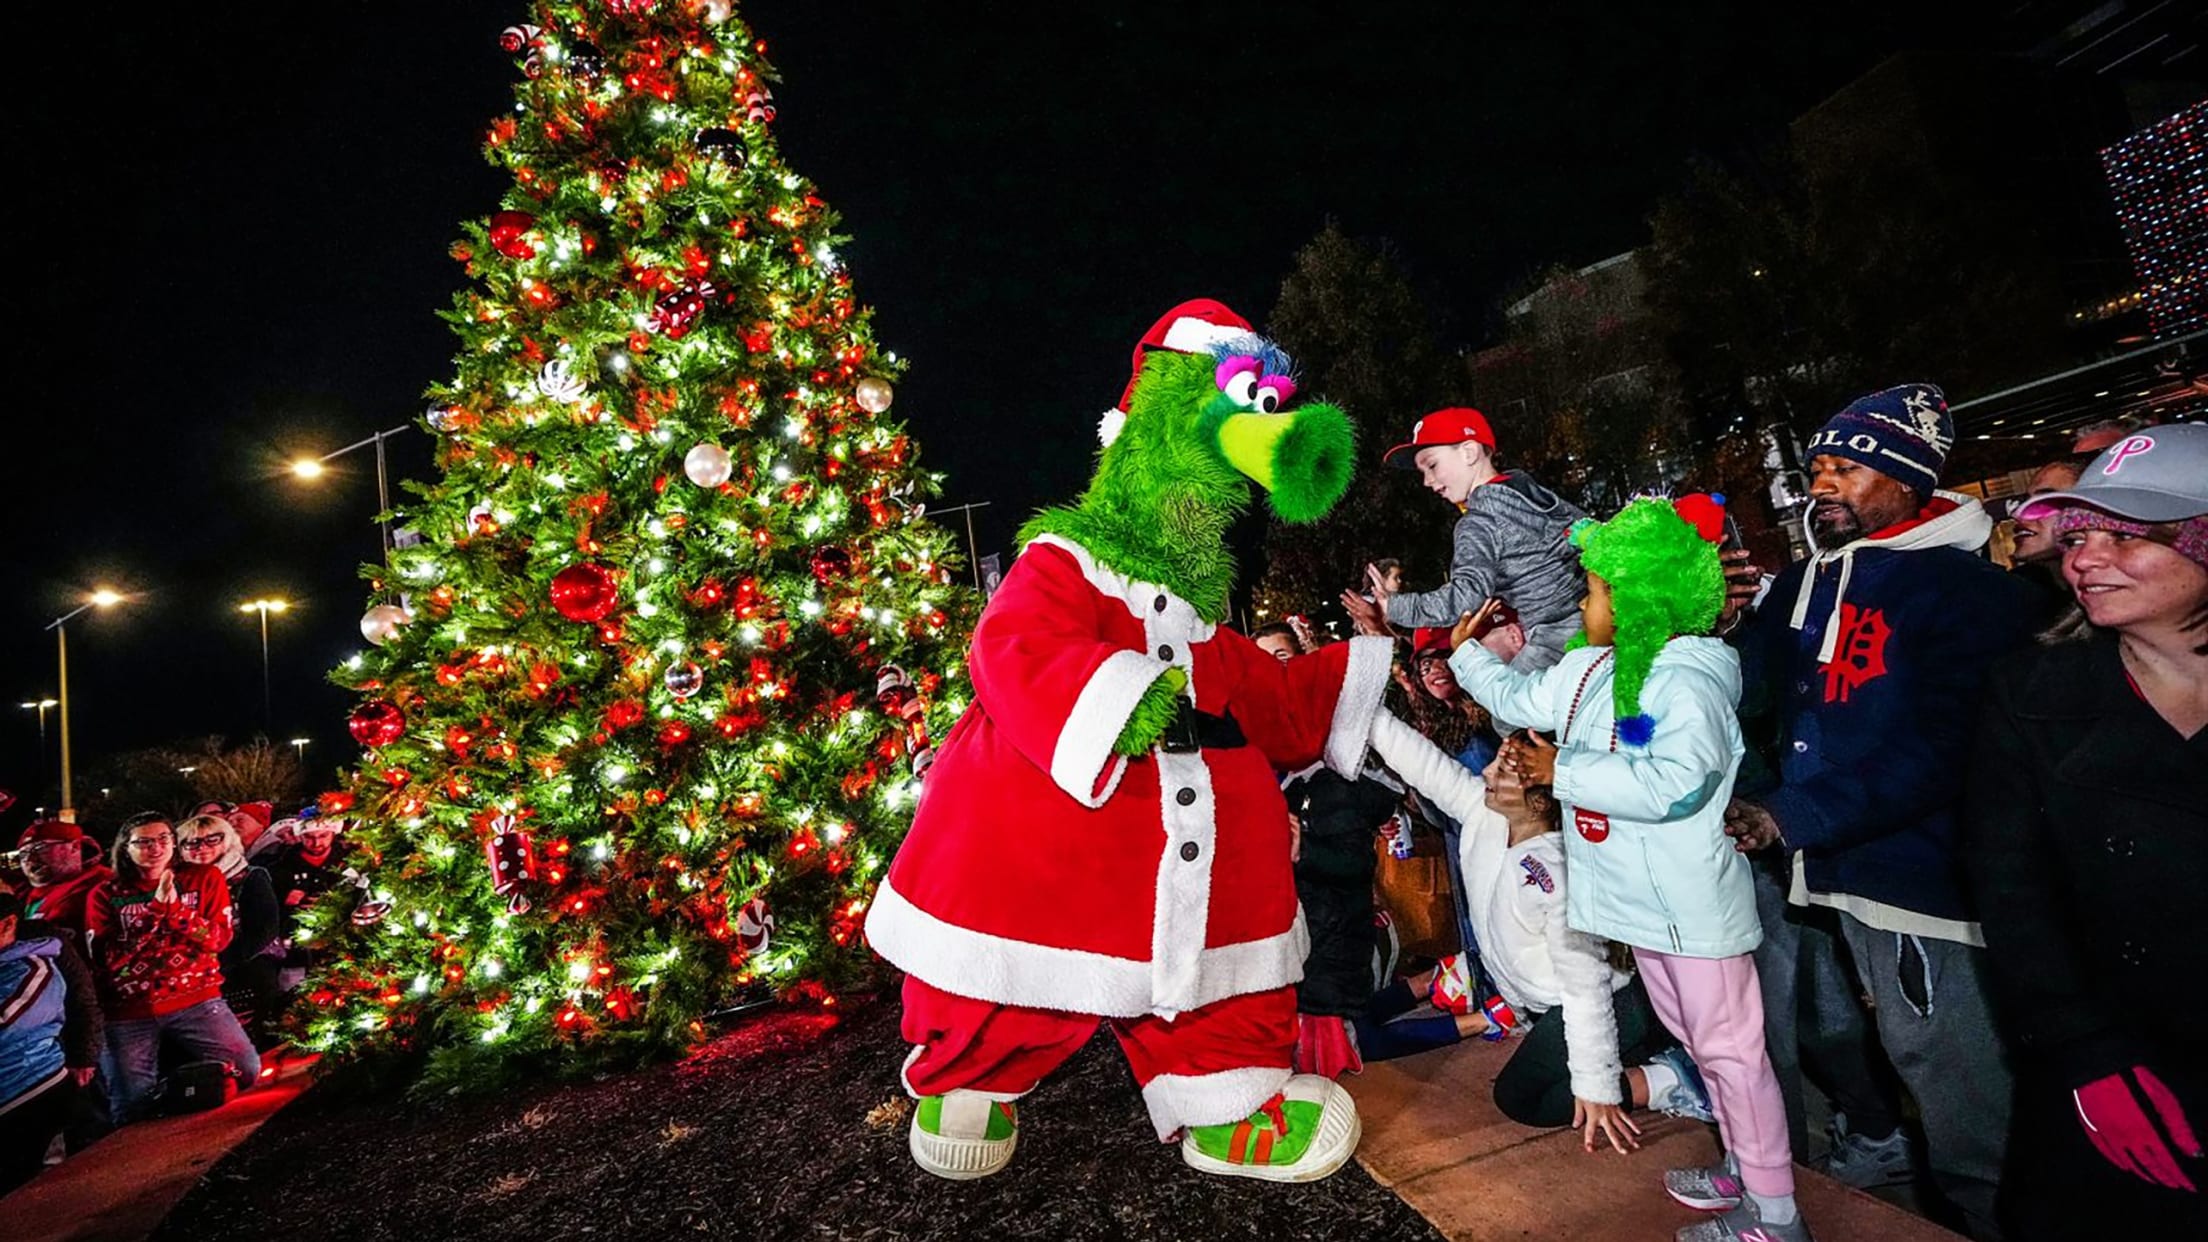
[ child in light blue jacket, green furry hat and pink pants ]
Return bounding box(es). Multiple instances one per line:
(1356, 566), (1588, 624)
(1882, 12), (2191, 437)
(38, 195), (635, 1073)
(1448, 495), (1808, 1242)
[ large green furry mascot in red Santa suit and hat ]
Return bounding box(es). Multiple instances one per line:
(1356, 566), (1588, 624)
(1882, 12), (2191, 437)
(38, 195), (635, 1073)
(866, 301), (1391, 1182)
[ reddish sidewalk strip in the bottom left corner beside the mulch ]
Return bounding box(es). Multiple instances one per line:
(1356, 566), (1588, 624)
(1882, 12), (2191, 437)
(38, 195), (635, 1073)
(0, 1056), (314, 1242)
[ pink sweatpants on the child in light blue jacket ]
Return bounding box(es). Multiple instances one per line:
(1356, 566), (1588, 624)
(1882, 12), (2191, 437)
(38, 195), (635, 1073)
(1634, 948), (1793, 1198)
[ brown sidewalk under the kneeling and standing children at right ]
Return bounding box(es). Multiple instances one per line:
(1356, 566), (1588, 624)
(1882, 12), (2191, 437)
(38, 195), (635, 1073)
(1342, 1041), (1956, 1242)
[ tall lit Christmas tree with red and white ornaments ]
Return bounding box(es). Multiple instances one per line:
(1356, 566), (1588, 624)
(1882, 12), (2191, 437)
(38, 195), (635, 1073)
(296, 0), (972, 1074)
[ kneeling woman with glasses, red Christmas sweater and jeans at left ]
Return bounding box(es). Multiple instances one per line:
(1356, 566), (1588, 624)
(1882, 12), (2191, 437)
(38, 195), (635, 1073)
(86, 811), (261, 1123)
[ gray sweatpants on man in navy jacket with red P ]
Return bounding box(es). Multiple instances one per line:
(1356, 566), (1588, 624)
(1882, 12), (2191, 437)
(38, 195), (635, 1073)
(1839, 913), (2014, 1242)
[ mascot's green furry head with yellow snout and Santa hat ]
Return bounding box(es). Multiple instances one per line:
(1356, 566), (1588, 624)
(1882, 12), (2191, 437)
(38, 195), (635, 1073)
(1020, 298), (1356, 621)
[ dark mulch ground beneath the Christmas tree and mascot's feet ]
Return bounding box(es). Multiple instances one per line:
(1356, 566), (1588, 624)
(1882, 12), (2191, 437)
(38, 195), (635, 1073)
(155, 992), (1440, 1242)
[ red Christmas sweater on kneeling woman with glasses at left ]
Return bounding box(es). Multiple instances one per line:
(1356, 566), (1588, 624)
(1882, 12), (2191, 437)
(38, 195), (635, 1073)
(86, 862), (232, 1021)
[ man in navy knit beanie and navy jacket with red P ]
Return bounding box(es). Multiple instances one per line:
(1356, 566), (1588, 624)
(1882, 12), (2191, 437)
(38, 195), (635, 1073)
(1727, 382), (2042, 1238)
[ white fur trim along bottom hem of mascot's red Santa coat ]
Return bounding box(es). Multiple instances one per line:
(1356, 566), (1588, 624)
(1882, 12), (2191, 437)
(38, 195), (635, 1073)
(866, 870), (1312, 1019)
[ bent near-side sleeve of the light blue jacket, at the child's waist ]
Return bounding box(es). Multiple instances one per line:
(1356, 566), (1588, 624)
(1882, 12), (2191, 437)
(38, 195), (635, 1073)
(1557, 665), (1740, 824)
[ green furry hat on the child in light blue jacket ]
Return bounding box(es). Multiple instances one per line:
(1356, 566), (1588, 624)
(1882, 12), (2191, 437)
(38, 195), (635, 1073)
(1572, 493), (1724, 747)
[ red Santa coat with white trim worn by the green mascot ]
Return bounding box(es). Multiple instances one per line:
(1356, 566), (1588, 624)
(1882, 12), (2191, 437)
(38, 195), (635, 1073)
(866, 535), (1393, 1017)
